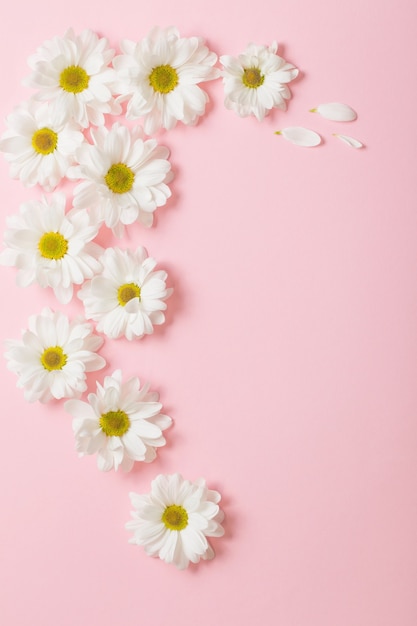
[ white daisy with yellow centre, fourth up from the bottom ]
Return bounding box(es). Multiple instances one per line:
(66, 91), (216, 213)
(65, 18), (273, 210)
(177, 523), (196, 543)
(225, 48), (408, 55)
(78, 246), (173, 340)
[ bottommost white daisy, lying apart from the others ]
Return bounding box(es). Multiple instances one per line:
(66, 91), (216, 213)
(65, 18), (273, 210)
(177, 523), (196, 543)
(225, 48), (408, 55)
(126, 474), (224, 569)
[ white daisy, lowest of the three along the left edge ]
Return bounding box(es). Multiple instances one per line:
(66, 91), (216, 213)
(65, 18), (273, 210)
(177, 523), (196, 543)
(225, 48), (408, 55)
(5, 309), (106, 402)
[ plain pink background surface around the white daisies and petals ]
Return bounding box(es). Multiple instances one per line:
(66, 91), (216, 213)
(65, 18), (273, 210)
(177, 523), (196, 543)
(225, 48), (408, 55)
(0, 0), (417, 626)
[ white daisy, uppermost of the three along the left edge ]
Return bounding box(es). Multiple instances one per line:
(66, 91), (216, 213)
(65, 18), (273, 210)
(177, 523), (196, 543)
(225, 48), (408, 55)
(0, 101), (84, 191)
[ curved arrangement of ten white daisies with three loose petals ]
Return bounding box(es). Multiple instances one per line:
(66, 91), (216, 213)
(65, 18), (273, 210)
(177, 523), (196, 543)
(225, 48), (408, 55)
(0, 27), (362, 569)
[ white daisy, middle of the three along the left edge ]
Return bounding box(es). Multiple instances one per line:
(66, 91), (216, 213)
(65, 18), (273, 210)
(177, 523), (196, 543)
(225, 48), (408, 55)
(0, 193), (103, 304)
